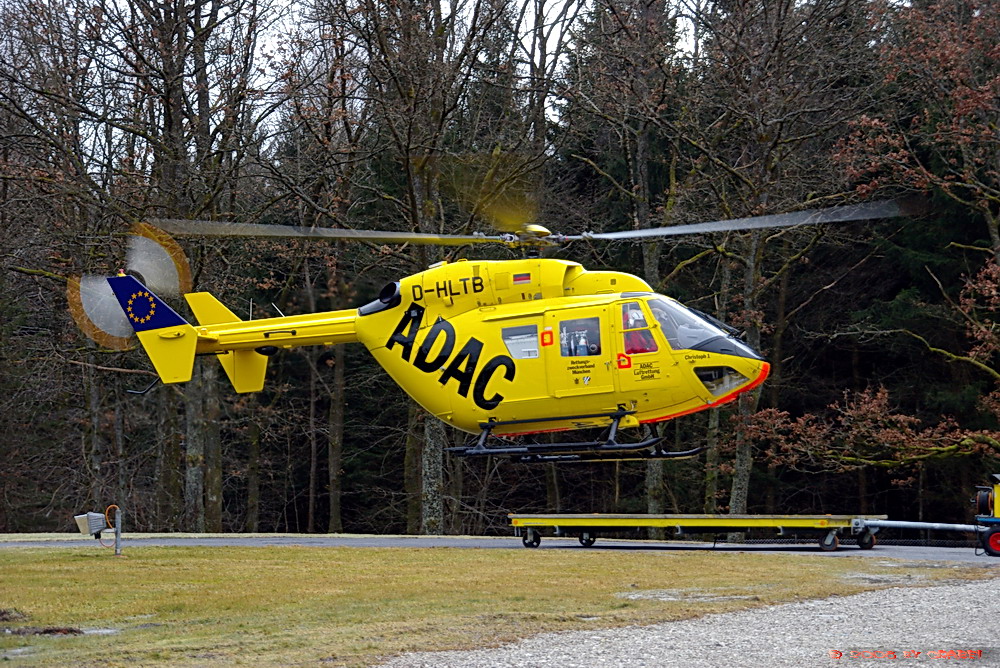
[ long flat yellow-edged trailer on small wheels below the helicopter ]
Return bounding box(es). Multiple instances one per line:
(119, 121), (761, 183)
(508, 513), (887, 551)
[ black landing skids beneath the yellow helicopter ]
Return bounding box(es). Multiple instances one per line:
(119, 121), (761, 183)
(448, 407), (704, 464)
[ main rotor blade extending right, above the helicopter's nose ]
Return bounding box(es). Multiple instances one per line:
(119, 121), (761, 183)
(560, 198), (922, 241)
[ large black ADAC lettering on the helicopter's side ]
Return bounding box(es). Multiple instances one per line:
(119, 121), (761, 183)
(385, 304), (515, 411)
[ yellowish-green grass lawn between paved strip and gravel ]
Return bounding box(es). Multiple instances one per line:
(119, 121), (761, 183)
(0, 547), (996, 666)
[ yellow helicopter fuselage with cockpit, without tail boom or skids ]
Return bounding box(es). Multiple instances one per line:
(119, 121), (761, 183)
(355, 259), (769, 435)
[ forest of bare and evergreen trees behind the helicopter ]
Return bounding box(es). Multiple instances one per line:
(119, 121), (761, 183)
(0, 0), (1000, 534)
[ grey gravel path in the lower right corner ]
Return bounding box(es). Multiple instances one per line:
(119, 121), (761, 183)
(384, 578), (1000, 668)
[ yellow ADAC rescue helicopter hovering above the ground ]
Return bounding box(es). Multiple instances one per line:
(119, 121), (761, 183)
(90, 196), (909, 462)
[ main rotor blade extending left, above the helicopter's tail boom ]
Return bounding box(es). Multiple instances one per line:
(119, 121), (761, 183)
(149, 218), (515, 246)
